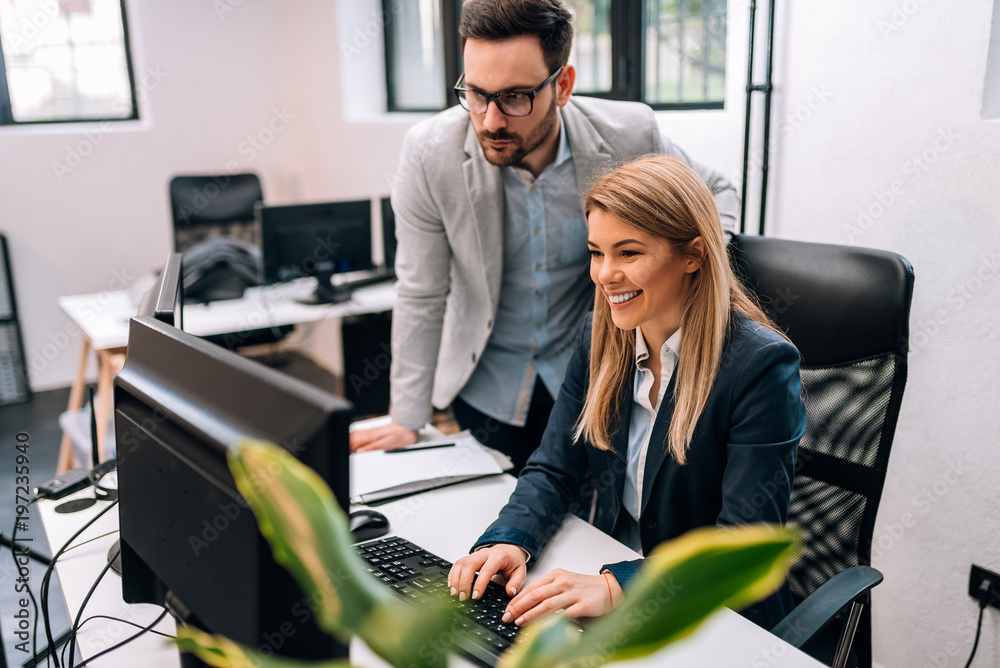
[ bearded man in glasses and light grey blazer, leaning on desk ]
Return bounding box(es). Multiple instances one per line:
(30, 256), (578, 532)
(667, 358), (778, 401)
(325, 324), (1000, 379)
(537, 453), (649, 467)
(351, 0), (739, 471)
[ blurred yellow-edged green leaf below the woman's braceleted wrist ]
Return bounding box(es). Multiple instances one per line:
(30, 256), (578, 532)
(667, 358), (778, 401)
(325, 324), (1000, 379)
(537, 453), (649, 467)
(503, 525), (799, 668)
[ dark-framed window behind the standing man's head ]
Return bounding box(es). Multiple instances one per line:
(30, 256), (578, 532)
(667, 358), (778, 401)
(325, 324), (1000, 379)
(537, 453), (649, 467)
(383, 0), (726, 111)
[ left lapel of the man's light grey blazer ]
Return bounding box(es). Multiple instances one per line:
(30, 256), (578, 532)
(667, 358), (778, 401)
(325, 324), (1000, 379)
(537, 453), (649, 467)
(462, 123), (504, 313)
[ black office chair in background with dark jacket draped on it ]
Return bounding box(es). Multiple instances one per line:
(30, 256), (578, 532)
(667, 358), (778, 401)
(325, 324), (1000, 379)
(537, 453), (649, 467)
(170, 173), (294, 350)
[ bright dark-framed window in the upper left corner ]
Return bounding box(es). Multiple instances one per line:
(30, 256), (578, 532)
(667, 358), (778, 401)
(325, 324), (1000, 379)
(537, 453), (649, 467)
(0, 0), (139, 125)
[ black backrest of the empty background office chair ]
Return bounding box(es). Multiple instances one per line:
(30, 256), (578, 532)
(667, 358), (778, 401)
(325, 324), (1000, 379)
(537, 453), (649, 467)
(170, 174), (264, 253)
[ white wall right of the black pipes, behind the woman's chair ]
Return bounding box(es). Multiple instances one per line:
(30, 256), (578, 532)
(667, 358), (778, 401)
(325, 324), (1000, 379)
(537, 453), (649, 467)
(770, 0), (1000, 667)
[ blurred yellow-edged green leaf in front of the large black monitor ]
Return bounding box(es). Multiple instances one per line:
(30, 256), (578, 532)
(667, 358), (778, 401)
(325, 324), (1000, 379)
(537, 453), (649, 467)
(229, 439), (452, 666)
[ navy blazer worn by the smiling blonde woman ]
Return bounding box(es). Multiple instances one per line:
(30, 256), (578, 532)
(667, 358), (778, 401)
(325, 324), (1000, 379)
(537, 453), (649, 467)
(473, 311), (806, 628)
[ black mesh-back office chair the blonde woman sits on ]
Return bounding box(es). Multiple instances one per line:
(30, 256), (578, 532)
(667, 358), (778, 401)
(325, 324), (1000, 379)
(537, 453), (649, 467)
(730, 235), (913, 667)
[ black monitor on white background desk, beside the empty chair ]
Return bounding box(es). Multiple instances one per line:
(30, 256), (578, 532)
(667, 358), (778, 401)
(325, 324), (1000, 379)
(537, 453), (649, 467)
(257, 200), (373, 304)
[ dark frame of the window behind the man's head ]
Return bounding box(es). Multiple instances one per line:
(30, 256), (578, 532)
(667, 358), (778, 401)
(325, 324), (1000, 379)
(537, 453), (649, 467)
(382, 0), (728, 113)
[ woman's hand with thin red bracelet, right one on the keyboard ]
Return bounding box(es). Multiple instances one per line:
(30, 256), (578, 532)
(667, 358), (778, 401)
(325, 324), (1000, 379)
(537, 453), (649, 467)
(503, 568), (622, 626)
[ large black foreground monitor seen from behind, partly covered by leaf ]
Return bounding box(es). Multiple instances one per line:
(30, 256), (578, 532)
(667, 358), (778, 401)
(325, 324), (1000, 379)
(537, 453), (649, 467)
(114, 315), (352, 659)
